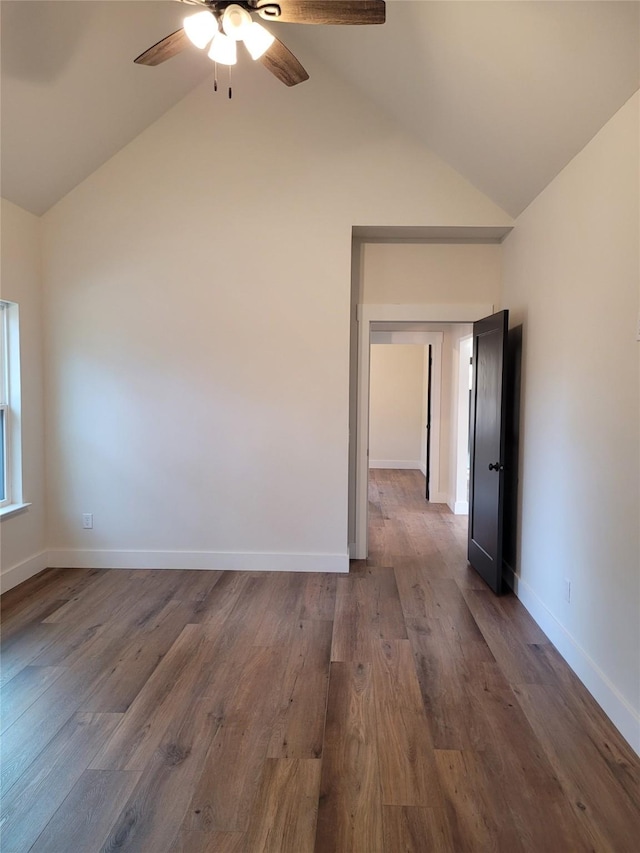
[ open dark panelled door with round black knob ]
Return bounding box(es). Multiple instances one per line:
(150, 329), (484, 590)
(468, 311), (509, 595)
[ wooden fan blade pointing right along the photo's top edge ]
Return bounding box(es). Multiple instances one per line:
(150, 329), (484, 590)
(256, 0), (385, 24)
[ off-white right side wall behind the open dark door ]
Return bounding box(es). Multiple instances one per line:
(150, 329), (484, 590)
(504, 90), (640, 750)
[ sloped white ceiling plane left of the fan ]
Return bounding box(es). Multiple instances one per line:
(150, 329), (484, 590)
(0, 0), (211, 215)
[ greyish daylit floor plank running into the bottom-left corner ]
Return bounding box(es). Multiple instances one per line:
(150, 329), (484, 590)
(0, 714), (120, 853)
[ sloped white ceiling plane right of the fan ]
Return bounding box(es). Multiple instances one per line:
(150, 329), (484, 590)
(284, 0), (640, 216)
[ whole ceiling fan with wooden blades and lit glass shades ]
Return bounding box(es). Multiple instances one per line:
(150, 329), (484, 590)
(134, 0), (385, 89)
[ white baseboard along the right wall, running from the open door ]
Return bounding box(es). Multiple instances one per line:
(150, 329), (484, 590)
(505, 567), (640, 755)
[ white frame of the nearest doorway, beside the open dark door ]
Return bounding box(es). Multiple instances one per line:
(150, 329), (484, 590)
(350, 303), (494, 560)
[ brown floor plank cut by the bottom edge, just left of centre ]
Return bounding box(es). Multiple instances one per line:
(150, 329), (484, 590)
(245, 759), (321, 853)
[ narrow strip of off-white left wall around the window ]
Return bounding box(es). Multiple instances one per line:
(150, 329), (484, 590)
(0, 199), (46, 590)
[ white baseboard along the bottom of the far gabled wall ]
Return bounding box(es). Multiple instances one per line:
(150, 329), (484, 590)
(48, 548), (349, 572)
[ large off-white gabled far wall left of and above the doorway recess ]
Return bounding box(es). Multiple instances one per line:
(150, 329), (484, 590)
(44, 61), (510, 570)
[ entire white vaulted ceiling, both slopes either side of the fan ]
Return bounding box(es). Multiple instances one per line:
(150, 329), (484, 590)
(1, 0), (640, 215)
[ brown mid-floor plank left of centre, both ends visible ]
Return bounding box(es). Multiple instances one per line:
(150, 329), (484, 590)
(267, 620), (333, 758)
